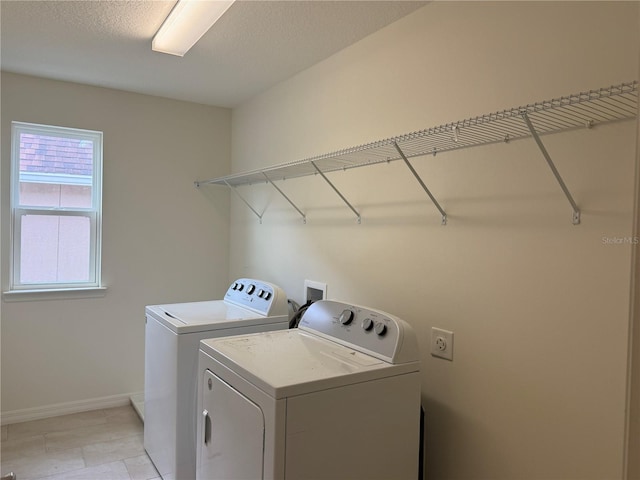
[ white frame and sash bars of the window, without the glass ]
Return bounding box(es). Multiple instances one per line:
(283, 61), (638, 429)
(10, 122), (103, 293)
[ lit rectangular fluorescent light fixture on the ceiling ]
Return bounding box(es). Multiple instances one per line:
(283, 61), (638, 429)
(151, 0), (235, 57)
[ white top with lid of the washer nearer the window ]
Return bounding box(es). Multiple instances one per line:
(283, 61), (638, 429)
(145, 300), (287, 333)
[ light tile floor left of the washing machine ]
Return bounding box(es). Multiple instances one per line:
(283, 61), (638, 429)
(0, 405), (160, 480)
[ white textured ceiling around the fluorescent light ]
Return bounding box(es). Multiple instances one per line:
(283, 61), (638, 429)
(0, 0), (426, 107)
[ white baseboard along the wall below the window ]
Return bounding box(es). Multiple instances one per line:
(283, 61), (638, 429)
(0, 392), (140, 426)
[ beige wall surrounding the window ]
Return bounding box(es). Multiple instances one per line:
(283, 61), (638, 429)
(2, 73), (231, 420)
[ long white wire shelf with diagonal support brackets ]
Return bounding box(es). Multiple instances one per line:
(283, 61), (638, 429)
(195, 81), (638, 224)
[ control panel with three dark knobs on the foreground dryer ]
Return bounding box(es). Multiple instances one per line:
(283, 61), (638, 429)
(299, 300), (419, 363)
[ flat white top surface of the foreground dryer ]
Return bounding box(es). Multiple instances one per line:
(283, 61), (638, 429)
(200, 329), (419, 399)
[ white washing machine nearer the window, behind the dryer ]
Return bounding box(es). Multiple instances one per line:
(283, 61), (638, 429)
(144, 278), (289, 480)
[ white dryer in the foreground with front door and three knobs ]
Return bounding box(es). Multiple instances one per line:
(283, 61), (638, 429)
(196, 300), (420, 480)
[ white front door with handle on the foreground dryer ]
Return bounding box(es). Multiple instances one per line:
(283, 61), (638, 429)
(196, 370), (264, 480)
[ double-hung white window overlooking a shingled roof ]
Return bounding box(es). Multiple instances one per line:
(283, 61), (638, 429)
(11, 122), (102, 291)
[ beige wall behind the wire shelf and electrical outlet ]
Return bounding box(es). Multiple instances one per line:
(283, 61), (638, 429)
(230, 2), (639, 480)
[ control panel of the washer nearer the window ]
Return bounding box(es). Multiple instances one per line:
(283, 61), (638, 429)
(224, 278), (288, 315)
